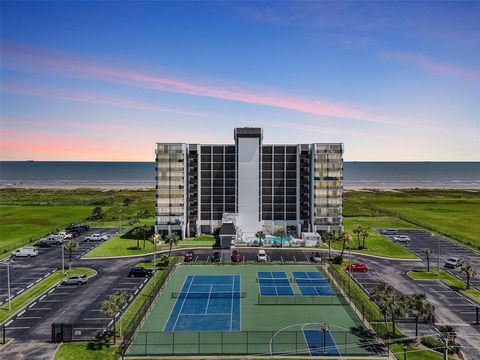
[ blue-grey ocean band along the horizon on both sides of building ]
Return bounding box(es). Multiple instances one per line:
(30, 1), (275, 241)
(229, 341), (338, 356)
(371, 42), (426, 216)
(0, 161), (480, 189)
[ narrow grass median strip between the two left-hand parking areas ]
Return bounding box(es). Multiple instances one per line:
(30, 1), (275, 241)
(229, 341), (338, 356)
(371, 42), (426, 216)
(0, 267), (97, 323)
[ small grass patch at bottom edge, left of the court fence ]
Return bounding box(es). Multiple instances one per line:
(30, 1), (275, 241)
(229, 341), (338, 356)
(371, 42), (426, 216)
(54, 342), (120, 360)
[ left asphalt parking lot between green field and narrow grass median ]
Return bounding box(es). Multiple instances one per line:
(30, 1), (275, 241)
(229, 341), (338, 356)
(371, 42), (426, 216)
(0, 228), (119, 305)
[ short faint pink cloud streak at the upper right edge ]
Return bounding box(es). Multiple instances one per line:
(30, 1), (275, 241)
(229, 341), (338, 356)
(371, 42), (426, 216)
(380, 51), (480, 81)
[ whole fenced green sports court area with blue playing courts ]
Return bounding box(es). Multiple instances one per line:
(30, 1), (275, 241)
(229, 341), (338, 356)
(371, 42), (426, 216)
(127, 265), (383, 357)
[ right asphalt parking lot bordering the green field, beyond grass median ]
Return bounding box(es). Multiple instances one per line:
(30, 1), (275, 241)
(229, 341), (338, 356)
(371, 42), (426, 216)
(388, 230), (480, 289)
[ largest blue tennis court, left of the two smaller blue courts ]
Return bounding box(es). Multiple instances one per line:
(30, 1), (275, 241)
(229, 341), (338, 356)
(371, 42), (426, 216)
(164, 275), (240, 332)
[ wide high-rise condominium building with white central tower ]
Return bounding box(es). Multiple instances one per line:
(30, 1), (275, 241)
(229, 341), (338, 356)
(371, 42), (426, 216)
(156, 128), (343, 237)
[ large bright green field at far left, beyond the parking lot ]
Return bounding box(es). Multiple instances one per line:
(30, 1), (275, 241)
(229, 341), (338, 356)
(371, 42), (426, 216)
(0, 205), (92, 253)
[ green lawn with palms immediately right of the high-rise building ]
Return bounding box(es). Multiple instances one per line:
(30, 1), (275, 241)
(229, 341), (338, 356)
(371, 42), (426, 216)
(332, 216), (417, 259)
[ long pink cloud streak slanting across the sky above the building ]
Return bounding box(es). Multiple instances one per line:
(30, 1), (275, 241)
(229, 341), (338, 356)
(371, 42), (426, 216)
(3, 44), (391, 123)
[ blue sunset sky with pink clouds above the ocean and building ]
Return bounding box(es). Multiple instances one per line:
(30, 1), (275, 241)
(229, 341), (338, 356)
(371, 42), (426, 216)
(0, 1), (480, 161)
